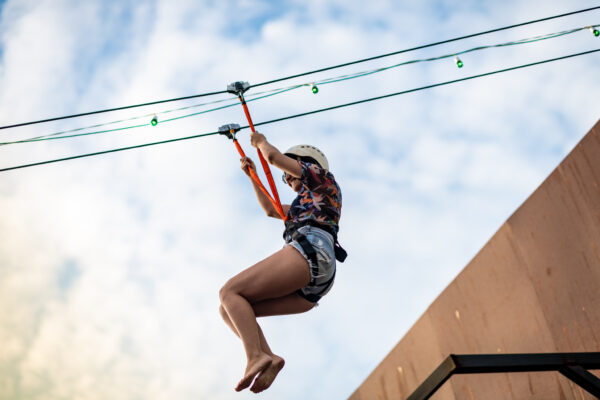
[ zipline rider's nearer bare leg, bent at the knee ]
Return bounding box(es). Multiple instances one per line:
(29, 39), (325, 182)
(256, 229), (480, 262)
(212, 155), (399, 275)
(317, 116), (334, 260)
(219, 246), (310, 391)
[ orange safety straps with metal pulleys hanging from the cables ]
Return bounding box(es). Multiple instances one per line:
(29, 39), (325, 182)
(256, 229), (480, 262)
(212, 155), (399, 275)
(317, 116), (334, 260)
(219, 82), (287, 222)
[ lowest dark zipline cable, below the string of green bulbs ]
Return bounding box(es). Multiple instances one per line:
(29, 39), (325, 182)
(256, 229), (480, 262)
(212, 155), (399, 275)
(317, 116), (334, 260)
(0, 49), (600, 172)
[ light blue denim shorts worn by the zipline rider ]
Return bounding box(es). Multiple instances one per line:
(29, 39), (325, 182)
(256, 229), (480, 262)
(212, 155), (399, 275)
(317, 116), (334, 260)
(286, 225), (335, 303)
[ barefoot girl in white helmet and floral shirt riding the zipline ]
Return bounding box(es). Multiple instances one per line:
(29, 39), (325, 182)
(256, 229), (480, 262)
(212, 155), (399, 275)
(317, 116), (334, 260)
(219, 132), (345, 393)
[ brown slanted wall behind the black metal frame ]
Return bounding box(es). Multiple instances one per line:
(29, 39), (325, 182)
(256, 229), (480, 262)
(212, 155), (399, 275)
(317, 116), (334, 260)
(350, 121), (600, 400)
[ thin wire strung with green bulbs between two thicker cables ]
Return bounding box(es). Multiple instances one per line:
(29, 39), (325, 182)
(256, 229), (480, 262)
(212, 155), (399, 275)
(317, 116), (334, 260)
(0, 25), (600, 146)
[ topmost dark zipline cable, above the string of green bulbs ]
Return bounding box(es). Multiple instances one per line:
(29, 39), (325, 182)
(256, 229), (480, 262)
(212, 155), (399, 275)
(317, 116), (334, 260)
(0, 6), (600, 130)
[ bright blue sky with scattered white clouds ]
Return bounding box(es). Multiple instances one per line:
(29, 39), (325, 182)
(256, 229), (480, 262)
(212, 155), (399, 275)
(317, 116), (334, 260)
(0, 0), (600, 400)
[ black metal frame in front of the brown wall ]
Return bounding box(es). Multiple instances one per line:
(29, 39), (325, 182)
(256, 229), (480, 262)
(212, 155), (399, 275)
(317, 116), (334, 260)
(406, 353), (600, 400)
